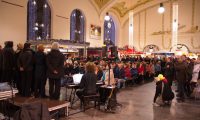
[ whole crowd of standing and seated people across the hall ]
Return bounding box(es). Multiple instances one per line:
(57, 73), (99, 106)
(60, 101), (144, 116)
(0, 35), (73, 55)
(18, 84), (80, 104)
(0, 41), (200, 105)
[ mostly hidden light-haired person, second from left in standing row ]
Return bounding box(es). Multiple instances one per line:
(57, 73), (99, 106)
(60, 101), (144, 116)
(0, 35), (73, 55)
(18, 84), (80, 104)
(14, 44), (24, 94)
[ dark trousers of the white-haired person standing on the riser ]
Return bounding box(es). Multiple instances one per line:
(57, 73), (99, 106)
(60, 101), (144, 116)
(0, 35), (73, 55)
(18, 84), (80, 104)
(49, 78), (61, 100)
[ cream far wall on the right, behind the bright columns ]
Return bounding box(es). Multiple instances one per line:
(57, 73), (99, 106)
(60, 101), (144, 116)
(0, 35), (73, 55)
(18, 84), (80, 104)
(122, 0), (200, 52)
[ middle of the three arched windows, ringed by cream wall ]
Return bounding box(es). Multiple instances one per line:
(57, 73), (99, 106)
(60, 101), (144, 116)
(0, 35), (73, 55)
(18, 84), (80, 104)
(70, 9), (85, 43)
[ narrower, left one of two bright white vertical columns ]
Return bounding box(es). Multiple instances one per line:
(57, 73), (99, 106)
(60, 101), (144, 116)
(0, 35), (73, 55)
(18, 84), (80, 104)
(128, 11), (134, 47)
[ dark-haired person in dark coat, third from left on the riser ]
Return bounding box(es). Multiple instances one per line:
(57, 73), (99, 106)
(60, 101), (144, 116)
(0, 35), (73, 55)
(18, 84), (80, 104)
(18, 43), (33, 97)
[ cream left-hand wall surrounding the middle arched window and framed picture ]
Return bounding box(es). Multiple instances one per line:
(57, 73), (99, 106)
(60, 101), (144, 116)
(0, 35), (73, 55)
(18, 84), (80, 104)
(0, 0), (103, 47)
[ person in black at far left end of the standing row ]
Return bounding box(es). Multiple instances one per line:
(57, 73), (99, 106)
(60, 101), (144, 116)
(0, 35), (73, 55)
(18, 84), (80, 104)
(2, 41), (15, 83)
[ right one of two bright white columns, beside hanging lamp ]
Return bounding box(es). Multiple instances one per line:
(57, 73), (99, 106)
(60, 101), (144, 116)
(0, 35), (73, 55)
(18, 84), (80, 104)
(172, 2), (178, 47)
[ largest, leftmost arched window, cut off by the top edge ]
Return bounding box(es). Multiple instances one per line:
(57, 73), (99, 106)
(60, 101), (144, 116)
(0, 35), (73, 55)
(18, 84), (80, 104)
(27, 0), (51, 40)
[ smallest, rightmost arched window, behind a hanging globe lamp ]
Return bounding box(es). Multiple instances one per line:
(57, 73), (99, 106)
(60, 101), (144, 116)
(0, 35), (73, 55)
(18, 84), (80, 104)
(104, 17), (115, 45)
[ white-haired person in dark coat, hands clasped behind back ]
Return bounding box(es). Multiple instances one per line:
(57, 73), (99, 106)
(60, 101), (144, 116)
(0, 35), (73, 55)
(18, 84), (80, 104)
(46, 42), (65, 99)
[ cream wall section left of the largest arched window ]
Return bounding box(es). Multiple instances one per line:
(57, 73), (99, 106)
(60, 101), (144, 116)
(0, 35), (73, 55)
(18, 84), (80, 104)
(0, 0), (27, 46)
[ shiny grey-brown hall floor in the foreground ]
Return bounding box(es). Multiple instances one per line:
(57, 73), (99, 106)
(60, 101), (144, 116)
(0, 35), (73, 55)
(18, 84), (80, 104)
(64, 82), (200, 120)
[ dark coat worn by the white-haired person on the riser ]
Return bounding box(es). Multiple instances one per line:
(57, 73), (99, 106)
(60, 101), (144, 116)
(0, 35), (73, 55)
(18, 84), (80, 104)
(46, 50), (65, 79)
